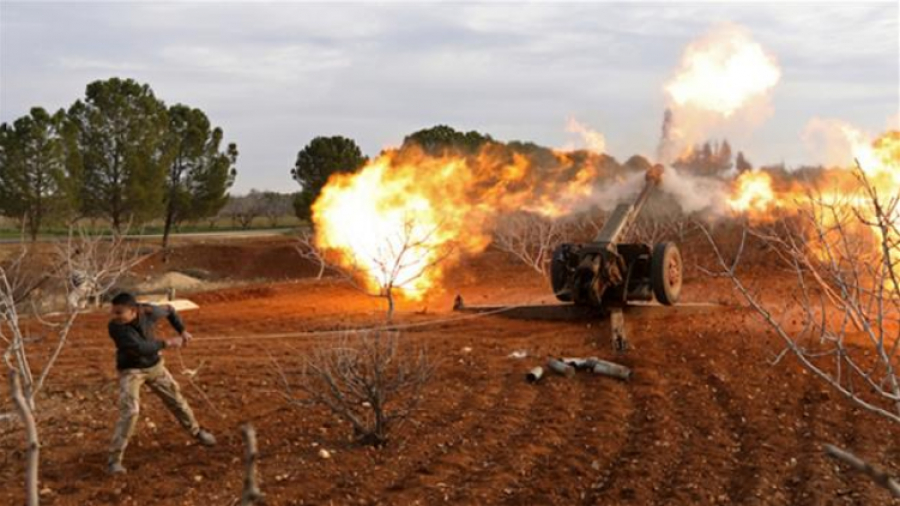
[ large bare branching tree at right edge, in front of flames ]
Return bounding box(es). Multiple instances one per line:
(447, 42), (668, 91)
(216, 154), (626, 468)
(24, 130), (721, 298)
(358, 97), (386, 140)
(702, 167), (900, 498)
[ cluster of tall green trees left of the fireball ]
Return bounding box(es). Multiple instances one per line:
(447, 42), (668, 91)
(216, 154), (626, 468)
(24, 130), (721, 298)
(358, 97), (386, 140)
(0, 78), (238, 246)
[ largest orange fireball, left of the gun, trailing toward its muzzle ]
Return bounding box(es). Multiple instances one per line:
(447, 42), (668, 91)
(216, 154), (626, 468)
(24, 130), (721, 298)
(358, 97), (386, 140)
(313, 144), (602, 300)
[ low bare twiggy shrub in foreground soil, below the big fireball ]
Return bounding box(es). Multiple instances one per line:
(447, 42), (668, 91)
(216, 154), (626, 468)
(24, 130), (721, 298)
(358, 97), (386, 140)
(275, 330), (434, 446)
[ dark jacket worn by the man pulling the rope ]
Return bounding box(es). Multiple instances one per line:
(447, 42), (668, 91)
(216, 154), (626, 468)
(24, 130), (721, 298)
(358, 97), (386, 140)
(109, 304), (184, 370)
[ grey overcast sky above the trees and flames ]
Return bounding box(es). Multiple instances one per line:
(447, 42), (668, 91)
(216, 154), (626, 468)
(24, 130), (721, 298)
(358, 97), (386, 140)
(0, 0), (900, 192)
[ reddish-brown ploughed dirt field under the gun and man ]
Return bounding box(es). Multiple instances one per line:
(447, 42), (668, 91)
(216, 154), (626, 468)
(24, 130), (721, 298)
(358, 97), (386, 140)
(0, 238), (900, 506)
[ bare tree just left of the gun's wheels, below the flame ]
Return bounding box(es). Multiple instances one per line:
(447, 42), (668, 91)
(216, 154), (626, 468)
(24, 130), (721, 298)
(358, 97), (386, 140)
(493, 212), (576, 278)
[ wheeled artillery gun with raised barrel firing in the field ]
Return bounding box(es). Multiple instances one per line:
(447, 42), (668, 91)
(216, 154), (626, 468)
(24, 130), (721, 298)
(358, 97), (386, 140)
(550, 165), (682, 310)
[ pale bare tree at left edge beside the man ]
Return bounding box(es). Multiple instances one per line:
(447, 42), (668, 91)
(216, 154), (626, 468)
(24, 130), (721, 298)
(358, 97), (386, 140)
(0, 227), (137, 506)
